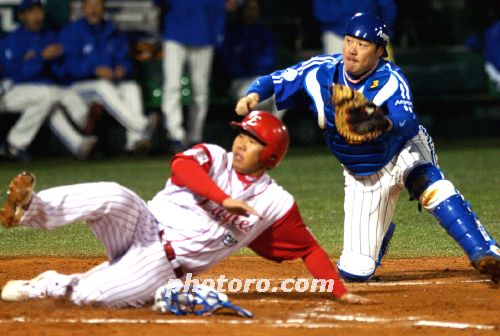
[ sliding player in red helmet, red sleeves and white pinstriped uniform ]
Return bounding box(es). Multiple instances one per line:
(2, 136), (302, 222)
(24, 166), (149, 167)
(0, 111), (373, 308)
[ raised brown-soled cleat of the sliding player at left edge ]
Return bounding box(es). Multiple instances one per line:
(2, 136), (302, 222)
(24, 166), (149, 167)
(0, 172), (36, 228)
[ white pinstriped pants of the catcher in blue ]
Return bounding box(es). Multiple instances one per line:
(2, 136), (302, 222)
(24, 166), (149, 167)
(341, 127), (437, 260)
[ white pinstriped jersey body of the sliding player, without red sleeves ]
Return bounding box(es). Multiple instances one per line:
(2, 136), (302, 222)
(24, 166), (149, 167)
(148, 144), (294, 274)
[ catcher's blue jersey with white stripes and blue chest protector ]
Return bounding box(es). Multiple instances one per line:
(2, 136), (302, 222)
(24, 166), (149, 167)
(248, 55), (420, 175)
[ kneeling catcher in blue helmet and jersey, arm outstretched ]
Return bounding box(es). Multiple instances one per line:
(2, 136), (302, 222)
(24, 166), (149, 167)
(236, 13), (500, 281)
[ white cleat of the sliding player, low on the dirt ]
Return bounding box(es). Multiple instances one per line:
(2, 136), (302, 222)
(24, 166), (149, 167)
(1, 271), (57, 301)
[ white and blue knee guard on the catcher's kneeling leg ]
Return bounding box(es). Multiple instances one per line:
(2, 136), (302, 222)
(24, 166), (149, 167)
(337, 252), (376, 282)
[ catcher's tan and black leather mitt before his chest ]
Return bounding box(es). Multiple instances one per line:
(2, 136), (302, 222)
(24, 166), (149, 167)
(332, 84), (390, 145)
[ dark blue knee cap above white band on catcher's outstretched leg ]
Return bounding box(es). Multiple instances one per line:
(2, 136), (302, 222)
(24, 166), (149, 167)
(405, 163), (444, 200)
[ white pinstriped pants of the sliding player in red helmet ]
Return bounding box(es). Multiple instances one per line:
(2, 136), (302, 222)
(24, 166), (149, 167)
(21, 182), (175, 308)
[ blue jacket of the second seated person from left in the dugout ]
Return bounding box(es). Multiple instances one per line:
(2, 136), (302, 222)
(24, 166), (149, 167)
(61, 18), (132, 81)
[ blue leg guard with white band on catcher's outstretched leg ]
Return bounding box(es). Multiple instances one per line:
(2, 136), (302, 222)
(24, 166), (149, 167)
(405, 164), (496, 265)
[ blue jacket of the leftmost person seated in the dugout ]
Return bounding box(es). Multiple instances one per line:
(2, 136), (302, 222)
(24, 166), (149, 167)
(2, 27), (62, 83)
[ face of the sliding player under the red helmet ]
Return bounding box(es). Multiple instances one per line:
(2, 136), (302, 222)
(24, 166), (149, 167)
(232, 133), (266, 176)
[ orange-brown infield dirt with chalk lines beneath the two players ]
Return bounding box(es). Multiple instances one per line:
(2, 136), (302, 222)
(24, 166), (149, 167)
(0, 257), (500, 336)
